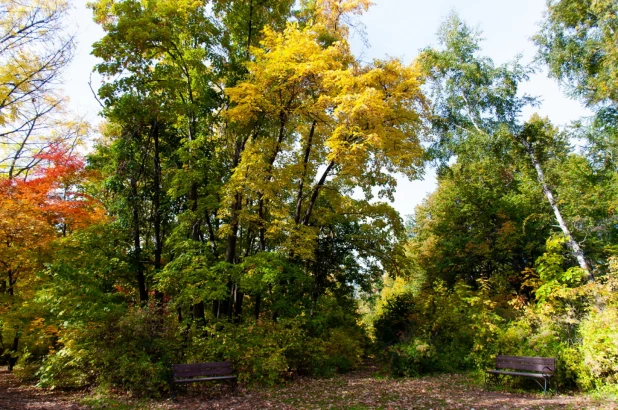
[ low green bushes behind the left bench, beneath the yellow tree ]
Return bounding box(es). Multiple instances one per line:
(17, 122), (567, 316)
(185, 318), (364, 385)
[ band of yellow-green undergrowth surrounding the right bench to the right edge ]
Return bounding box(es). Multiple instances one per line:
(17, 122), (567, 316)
(364, 248), (618, 394)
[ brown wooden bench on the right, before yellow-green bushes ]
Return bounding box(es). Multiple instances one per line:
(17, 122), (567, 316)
(487, 355), (556, 393)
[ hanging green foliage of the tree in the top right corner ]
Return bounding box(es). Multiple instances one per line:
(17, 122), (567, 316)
(535, 0), (618, 272)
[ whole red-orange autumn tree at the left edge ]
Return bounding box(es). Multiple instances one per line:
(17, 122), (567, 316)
(0, 145), (104, 370)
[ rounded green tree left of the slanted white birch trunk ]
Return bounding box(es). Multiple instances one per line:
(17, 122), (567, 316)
(409, 155), (552, 288)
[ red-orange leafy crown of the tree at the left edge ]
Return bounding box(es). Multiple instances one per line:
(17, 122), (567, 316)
(0, 145), (104, 294)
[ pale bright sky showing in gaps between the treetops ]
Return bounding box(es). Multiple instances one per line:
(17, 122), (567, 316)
(64, 0), (589, 216)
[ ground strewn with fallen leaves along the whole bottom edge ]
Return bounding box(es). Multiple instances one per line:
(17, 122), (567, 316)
(0, 369), (618, 410)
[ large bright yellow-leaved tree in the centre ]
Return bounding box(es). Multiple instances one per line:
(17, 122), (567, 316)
(220, 0), (425, 320)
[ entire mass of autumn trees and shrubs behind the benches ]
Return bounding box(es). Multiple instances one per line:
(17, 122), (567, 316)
(0, 0), (618, 396)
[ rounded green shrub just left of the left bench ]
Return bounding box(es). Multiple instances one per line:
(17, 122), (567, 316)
(39, 307), (181, 397)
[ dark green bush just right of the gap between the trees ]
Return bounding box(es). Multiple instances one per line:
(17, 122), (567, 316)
(374, 282), (501, 376)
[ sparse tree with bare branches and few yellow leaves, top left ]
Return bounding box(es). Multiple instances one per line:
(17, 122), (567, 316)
(0, 0), (83, 179)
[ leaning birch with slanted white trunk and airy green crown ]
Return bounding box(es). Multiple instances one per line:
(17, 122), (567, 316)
(422, 15), (593, 280)
